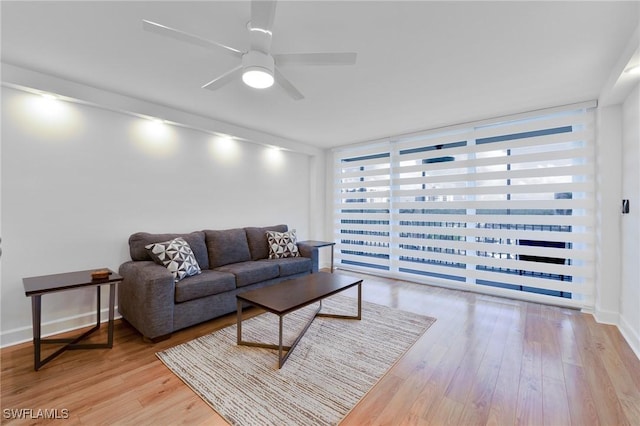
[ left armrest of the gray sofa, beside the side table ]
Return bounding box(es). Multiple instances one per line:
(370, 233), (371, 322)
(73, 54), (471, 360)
(118, 261), (175, 340)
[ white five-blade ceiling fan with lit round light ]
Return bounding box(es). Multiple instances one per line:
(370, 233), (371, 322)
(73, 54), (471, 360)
(142, 0), (357, 100)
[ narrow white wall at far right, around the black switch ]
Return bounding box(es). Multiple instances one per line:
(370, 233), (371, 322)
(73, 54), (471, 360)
(620, 85), (640, 357)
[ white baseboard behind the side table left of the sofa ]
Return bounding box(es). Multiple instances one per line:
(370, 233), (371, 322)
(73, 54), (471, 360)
(0, 307), (122, 348)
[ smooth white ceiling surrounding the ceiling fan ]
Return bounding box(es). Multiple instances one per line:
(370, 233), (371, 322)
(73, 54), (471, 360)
(1, 1), (640, 148)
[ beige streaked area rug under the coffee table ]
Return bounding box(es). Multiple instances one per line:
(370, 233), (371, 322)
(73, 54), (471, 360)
(156, 295), (435, 426)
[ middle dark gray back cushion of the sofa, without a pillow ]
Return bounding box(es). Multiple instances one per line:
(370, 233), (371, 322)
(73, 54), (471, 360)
(204, 228), (251, 269)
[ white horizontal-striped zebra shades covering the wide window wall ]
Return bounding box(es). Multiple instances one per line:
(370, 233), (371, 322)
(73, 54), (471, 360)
(334, 106), (595, 306)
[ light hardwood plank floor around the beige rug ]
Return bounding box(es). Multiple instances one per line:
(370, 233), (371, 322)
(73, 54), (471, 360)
(0, 272), (640, 426)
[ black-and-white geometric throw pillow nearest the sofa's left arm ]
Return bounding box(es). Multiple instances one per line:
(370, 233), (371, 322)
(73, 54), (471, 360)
(145, 237), (202, 282)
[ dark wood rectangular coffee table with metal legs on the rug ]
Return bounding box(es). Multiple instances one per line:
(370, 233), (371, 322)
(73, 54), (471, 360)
(236, 272), (362, 368)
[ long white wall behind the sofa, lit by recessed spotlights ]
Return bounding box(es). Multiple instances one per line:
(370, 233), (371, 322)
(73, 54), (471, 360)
(0, 87), (324, 346)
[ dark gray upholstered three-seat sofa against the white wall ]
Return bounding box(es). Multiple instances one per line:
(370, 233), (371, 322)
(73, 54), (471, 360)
(118, 225), (318, 341)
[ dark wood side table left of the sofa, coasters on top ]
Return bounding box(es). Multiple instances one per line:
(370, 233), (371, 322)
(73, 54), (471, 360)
(22, 270), (122, 371)
